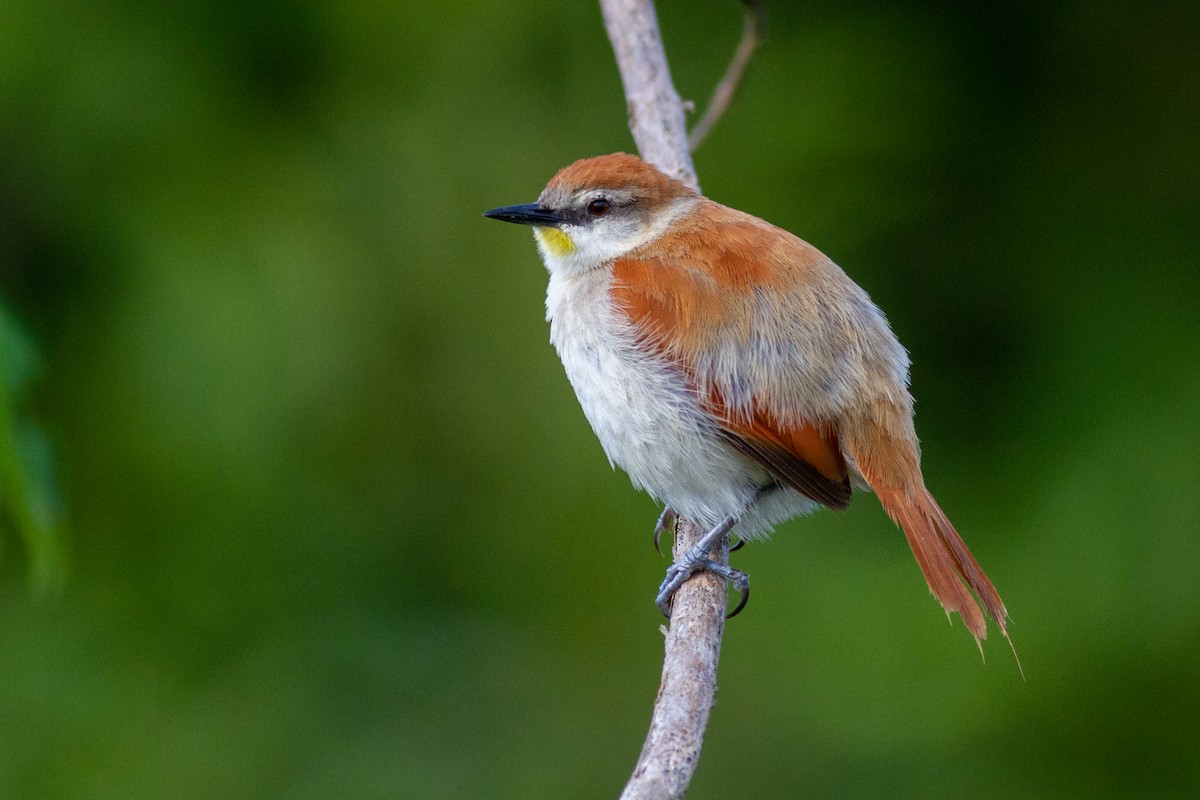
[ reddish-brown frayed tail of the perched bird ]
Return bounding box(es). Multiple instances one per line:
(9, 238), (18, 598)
(876, 486), (1008, 642)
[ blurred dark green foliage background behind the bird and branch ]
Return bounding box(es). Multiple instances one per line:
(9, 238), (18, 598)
(0, 0), (1200, 800)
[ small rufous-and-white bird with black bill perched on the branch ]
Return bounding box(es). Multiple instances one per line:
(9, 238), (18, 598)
(484, 152), (1015, 655)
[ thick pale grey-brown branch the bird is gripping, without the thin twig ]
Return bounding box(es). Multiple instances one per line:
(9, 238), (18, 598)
(600, 0), (730, 800)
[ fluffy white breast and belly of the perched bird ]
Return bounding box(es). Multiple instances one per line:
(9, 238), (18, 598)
(546, 269), (814, 536)
